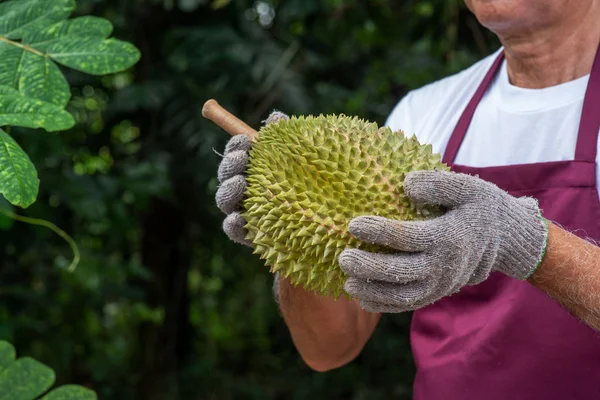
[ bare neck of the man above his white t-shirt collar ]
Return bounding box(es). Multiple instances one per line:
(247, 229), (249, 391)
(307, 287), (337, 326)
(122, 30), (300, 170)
(499, 2), (600, 89)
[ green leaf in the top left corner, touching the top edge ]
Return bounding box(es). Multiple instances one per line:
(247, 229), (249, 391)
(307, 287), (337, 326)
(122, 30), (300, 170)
(0, 0), (75, 39)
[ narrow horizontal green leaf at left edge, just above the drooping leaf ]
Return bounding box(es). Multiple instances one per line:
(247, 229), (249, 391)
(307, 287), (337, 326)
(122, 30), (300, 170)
(0, 86), (75, 132)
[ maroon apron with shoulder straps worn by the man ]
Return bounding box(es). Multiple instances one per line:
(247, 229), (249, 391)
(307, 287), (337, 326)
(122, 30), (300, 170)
(411, 47), (600, 400)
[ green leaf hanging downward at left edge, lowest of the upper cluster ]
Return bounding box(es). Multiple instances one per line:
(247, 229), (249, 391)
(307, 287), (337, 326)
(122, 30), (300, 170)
(0, 129), (40, 208)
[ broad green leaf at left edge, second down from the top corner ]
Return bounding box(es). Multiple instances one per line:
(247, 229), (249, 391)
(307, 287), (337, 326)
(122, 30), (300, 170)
(0, 42), (71, 108)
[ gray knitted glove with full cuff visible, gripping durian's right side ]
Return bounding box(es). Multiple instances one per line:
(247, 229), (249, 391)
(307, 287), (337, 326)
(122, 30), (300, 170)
(339, 171), (548, 312)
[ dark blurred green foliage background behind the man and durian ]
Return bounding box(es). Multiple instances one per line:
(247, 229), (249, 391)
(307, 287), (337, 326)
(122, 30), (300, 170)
(0, 0), (498, 400)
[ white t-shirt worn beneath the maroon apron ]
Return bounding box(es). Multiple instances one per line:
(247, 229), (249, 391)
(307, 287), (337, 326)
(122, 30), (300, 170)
(386, 49), (600, 195)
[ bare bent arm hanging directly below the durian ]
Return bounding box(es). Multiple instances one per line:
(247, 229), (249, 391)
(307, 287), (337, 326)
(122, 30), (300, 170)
(279, 279), (380, 371)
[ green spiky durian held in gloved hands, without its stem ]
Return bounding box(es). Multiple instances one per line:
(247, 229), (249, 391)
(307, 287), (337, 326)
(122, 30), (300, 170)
(242, 115), (448, 298)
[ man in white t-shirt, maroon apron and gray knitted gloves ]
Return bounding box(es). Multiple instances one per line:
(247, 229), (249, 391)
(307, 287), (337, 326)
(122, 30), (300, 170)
(217, 0), (600, 400)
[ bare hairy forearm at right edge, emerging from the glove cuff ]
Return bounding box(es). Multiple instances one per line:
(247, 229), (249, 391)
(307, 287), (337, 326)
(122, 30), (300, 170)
(529, 225), (600, 332)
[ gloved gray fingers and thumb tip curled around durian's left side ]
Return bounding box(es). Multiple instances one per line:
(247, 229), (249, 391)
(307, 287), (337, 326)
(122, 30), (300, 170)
(216, 111), (289, 247)
